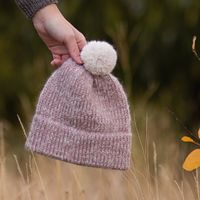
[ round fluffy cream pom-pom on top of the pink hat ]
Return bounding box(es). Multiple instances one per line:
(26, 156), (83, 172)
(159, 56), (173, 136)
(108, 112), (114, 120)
(81, 41), (117, 75)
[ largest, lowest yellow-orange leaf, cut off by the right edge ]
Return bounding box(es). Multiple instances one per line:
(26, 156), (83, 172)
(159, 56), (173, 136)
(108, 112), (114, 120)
(183, 149), (200, 171)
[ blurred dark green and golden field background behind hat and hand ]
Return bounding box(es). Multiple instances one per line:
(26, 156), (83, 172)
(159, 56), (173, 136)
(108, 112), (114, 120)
(0, 0), (200, 200)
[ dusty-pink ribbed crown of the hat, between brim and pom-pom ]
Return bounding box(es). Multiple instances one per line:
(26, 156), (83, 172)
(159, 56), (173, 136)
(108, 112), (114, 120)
(36, 59), (130, 133)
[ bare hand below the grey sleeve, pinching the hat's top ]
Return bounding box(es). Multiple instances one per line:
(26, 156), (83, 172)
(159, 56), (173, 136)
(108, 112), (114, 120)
(32, 4), (87, 67)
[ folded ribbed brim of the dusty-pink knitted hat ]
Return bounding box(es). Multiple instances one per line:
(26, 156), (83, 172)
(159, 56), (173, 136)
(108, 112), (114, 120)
(25, 115), (131, 170)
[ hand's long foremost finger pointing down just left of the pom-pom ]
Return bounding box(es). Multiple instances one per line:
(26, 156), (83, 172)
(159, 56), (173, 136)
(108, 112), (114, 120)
(64, 33), (83, 64)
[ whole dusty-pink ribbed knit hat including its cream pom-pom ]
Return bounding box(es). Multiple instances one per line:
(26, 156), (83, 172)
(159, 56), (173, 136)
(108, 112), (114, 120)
(25, 41), (132, 170)
